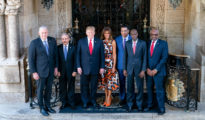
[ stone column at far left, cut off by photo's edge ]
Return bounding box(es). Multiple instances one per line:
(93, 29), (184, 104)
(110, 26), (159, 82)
(0, 0), (6, 61)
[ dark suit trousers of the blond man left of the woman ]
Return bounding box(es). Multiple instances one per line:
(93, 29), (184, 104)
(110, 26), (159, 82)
(80, 74), (98, 104)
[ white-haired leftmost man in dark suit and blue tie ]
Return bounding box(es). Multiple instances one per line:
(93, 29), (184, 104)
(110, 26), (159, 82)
(28, 26), (58, 116)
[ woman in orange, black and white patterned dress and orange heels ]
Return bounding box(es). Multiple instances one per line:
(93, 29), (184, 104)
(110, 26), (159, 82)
(99, 27), (119, 107)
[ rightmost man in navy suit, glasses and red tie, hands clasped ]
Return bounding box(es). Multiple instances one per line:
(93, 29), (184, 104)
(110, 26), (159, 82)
(144, 28), (168, 115)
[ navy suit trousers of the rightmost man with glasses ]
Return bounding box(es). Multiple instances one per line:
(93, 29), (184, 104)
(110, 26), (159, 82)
(146, 75), (165, 109)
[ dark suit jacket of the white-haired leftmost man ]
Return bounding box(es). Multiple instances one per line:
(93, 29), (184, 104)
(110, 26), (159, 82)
(28, 37), (58, 78)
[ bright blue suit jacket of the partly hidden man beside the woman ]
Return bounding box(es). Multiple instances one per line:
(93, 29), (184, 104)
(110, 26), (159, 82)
(115, 35), (132, 69)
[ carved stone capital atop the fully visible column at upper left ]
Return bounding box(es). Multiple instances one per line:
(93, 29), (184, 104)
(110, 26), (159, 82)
(5, 0), (21, 15)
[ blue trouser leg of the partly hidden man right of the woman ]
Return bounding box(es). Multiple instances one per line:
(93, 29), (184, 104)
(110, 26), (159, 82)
(118, 69), (126, 101)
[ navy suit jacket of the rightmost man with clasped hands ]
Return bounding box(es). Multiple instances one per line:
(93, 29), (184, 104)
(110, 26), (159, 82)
(147, 39), (168, 76)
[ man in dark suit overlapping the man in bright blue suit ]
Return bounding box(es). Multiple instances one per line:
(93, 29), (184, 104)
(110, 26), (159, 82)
(123, 29), (147, 112)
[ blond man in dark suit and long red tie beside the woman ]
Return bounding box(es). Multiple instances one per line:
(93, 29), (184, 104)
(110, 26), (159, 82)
(77, 26), (105, 108)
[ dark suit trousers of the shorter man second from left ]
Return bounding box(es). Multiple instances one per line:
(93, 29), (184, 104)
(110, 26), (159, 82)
(59, 72), (75, 106)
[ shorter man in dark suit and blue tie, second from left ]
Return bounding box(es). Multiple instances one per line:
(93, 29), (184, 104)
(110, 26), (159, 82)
(58, 33), (77, 109)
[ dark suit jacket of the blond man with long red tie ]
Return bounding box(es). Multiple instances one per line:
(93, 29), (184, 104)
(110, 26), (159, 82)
(77, 37), (105, 75)
